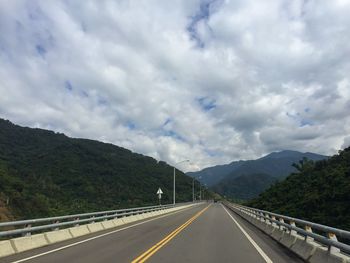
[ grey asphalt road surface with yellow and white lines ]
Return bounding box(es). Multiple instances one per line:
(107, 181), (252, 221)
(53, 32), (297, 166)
(0, 203), (303, 263)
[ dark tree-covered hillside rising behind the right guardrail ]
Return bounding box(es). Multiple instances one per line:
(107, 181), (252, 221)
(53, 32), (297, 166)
(246, 147), (350, 230)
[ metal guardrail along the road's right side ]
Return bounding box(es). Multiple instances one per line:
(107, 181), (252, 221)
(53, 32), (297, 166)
(225, 202), (350, 255)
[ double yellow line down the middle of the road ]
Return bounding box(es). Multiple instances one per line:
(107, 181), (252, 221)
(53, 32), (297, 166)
(131, 205), (210, 263)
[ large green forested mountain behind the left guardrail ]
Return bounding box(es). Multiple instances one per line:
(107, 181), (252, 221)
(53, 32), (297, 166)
(0, 119), (204, 220)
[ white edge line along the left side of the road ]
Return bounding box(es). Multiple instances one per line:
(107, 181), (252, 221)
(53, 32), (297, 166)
(11, 206), (198, 263)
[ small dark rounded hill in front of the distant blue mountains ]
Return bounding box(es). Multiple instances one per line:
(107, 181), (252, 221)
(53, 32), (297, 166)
(212, 174), (277, 200)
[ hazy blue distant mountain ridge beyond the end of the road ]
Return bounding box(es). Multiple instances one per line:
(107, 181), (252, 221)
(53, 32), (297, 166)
(187, 150), (328, 199)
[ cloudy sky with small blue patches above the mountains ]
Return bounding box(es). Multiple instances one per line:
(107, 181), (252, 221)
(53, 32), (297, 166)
(0, 0), (350, 171)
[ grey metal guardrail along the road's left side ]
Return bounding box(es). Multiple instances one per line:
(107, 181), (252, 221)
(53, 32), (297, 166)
(0, 204), (174, 238)
